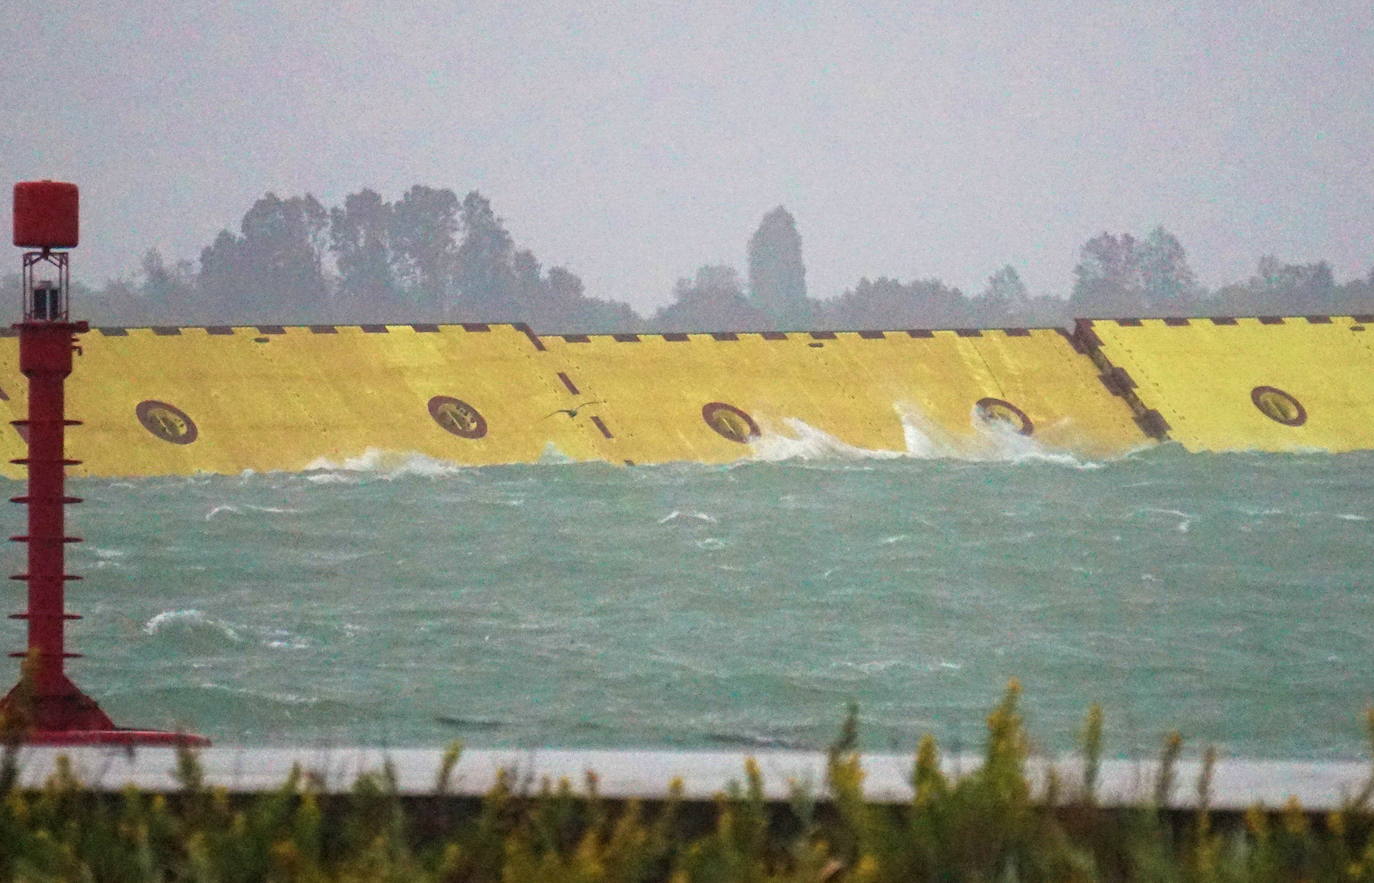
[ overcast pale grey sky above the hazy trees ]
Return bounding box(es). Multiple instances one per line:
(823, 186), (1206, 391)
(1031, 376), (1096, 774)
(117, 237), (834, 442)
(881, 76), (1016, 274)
(0, 0), (1374, 310)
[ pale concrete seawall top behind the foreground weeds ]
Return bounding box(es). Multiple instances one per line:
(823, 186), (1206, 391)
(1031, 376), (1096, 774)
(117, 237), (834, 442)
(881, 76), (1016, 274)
(19, 746), (1371, 812)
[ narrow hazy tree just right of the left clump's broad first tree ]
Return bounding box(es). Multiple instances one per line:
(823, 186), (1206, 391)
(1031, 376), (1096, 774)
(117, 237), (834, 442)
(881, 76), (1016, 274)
(330, 188), (396, 321)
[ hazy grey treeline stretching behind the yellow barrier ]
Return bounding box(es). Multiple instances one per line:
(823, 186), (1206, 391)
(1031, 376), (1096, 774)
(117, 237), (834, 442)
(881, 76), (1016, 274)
(0, 184), (1374, 332)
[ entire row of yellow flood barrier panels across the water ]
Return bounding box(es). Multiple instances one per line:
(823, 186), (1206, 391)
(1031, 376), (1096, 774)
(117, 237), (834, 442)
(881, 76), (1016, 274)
(0, 316), (1374, 478)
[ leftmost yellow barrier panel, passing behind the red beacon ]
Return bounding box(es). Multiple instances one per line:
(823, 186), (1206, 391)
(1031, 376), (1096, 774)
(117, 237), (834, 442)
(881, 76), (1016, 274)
(0, 325), (596, 477)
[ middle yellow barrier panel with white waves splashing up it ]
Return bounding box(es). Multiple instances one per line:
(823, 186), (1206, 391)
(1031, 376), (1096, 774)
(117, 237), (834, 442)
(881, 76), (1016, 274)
(543, 328), (1147, 463)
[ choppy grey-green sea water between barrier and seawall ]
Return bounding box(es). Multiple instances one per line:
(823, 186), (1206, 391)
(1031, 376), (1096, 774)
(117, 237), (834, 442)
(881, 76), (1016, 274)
(4, 445), (1374, 758)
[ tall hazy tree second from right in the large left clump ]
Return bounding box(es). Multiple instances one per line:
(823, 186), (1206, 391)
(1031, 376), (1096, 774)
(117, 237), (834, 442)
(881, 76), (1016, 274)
(392, 184), (458, 316)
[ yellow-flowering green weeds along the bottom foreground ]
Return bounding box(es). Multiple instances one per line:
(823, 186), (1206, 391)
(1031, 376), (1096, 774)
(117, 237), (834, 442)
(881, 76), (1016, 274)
(0, 684), (1374, 883)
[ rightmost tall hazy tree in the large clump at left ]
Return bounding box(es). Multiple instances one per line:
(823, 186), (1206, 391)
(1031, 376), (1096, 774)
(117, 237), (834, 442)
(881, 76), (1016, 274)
(453, 190), (519, 321)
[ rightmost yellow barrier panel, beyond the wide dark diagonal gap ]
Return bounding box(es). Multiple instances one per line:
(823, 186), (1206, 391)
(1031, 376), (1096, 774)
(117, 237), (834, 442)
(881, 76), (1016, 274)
(1077, 316), (1374, 452)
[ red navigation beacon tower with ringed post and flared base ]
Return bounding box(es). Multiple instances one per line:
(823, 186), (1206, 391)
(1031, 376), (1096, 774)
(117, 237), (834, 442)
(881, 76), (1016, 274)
(0, 181), (209, 746)
